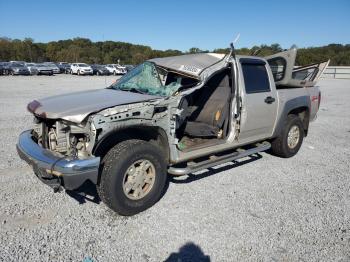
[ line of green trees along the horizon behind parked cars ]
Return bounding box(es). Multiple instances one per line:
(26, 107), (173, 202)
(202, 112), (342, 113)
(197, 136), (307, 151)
(0, 37), (350, 66)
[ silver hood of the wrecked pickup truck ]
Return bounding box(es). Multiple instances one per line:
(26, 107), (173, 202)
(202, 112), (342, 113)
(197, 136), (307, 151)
(27, 89), (159, 123)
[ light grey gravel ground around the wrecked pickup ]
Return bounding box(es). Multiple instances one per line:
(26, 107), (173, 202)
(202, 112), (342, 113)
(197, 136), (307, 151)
(0, 75), (350, 261)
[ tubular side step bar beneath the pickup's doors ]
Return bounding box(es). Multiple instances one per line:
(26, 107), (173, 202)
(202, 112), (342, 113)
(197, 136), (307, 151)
(168, 141), (271, 176)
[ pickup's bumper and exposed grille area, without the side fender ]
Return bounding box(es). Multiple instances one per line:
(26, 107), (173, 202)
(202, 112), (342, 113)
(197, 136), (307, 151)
(17, 116), (100, 192)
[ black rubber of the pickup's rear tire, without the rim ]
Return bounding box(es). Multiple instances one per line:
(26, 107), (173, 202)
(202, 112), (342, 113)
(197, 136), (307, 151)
(271, 115), (304, 158)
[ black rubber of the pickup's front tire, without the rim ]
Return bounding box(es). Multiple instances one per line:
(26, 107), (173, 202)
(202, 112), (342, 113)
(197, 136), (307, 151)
(97, 140), (167, 216)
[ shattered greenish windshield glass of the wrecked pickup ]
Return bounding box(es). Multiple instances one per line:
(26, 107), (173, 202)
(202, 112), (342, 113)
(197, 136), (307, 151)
(110, 62), (181, 96)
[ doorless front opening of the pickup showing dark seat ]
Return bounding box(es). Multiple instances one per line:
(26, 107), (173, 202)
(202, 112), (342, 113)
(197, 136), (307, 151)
(176, 67), (233, 151)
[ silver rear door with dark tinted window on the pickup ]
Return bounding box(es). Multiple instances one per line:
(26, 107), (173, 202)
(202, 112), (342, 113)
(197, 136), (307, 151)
(238, 58), (278, 142)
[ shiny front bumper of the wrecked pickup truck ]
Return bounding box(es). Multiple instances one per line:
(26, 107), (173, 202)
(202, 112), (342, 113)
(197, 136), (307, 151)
(17, 130), (100, 191)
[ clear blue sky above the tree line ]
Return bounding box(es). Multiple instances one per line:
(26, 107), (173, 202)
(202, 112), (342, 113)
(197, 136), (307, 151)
(0, 0), (350, 51)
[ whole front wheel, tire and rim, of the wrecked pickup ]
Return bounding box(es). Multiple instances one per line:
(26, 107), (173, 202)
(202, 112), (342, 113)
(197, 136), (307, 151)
(97, 140), (167, 216)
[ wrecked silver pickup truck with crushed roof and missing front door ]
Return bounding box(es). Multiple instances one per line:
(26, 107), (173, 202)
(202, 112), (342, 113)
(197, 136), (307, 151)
(17, 49), (328, 215)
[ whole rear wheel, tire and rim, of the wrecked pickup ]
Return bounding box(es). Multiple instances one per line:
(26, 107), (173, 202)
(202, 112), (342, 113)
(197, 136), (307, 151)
(271, 115), (304, 158)
